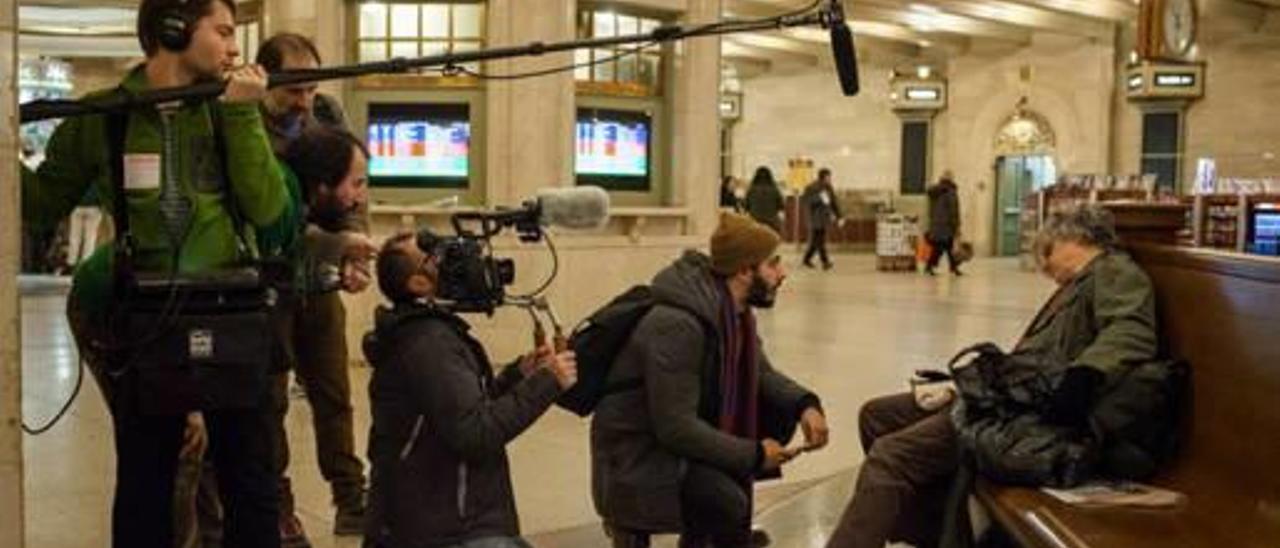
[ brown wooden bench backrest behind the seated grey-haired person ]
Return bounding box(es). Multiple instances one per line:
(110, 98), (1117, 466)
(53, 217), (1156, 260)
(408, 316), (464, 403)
(1132, 243), (1280, 504)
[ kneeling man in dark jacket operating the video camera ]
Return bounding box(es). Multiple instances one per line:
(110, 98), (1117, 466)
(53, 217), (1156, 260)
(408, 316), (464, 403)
(365, 233), (577, 548)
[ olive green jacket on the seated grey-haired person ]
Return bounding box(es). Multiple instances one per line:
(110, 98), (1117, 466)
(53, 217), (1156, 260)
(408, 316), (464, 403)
(1018, 251), (1157, 385)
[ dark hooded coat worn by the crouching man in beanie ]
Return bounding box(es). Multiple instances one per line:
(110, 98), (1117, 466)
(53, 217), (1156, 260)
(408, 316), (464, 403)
(591, 251), (818, 531)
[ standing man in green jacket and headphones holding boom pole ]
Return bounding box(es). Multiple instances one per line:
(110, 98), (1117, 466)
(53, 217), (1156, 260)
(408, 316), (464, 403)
(22, 0), (287, 548)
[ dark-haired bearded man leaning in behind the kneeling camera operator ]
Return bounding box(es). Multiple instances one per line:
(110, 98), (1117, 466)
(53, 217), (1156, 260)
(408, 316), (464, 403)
(266, 125), (372, 548)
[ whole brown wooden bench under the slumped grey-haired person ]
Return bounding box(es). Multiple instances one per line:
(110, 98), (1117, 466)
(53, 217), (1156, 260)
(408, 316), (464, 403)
(975, 243), (1280, 548)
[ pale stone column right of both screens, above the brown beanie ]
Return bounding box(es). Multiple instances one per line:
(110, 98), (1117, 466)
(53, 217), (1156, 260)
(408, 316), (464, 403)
(671, 0), (721, 236)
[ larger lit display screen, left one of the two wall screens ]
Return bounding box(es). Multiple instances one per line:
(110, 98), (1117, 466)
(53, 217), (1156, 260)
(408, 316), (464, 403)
(366, 104), (471, 188)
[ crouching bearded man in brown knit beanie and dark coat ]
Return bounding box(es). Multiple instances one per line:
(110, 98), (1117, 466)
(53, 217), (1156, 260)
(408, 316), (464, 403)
(591, 213), (827, 548)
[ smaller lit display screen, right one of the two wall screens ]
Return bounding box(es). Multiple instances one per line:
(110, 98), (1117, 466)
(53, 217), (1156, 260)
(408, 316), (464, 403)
(575, 109), (653, 191)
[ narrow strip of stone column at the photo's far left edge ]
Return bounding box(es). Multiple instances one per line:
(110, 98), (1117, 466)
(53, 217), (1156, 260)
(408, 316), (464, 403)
(0, 0), (24, 548)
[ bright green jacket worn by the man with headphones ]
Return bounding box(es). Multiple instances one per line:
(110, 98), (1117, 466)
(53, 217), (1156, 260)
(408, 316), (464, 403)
(22, 65), (289, 312)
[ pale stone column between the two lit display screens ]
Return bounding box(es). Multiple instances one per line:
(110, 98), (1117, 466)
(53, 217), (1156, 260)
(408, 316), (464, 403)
(484, 0), (575, 205)
